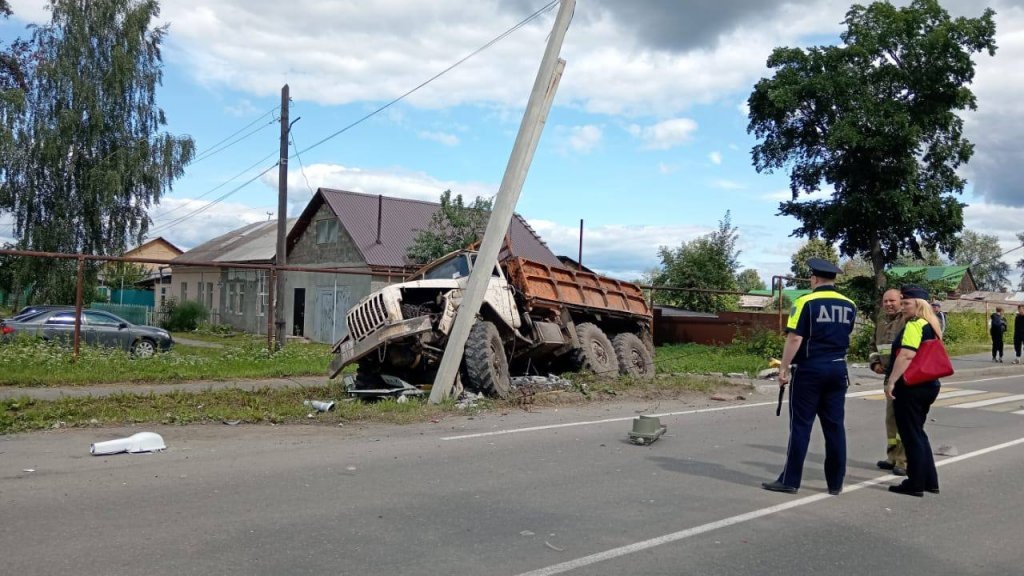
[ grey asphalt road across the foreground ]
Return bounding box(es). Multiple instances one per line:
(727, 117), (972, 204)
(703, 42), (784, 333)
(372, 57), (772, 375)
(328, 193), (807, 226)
(0, 366), (1024, 576)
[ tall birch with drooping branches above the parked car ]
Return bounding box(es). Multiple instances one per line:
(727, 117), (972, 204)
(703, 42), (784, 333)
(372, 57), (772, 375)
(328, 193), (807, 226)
(0, 0), (195, 301)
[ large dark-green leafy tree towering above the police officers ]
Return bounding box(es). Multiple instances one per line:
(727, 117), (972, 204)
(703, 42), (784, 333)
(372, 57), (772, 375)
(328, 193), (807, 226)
(748, 0), (996, 288)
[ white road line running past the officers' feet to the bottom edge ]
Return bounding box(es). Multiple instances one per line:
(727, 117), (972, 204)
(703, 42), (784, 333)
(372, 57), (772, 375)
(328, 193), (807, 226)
(518, 438), (1024, 576)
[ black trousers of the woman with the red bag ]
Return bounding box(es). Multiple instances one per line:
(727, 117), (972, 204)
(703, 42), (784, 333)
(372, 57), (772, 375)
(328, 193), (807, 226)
(893, 380), (939, 491)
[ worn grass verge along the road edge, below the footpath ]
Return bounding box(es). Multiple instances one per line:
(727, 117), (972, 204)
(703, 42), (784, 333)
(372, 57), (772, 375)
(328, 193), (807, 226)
(0, 376), (733, 434)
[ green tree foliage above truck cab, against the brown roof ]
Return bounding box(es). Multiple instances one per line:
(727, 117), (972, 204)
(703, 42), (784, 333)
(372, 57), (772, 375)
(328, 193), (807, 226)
(408, 190), (494, 264)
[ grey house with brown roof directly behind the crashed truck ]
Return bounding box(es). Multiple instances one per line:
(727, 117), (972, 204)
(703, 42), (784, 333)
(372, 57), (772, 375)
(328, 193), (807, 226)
(285, 188), (561, 342)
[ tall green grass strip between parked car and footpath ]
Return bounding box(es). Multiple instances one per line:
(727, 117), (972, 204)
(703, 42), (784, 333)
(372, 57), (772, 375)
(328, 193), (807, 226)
(0, 338), (330, 386)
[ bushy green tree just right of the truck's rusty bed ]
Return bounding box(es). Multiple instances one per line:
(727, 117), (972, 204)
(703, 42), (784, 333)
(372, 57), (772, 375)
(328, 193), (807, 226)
(653, 211), (739, 313)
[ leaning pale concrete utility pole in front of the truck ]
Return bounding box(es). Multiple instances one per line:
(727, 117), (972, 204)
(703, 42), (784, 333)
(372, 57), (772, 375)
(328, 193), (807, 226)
(430, 0), (575, 404)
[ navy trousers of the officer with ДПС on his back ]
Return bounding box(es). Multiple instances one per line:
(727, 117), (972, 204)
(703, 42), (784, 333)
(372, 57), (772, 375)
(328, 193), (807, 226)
(778, 362), (850, 490)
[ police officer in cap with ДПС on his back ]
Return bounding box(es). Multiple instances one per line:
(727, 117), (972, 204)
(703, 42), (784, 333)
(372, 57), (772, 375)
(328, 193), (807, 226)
(761, 258), (857, 496)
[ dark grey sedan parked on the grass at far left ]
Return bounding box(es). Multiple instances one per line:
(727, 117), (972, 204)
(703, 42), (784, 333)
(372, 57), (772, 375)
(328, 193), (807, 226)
(0, 307), (174, 358)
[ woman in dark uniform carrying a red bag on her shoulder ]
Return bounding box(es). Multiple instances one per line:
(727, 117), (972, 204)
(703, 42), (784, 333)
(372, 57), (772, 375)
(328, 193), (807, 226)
(886, 284), (942, 497)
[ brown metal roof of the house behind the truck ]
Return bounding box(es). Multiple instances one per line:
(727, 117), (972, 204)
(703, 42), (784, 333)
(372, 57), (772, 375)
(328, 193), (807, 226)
(299, 188), (564, 268)
